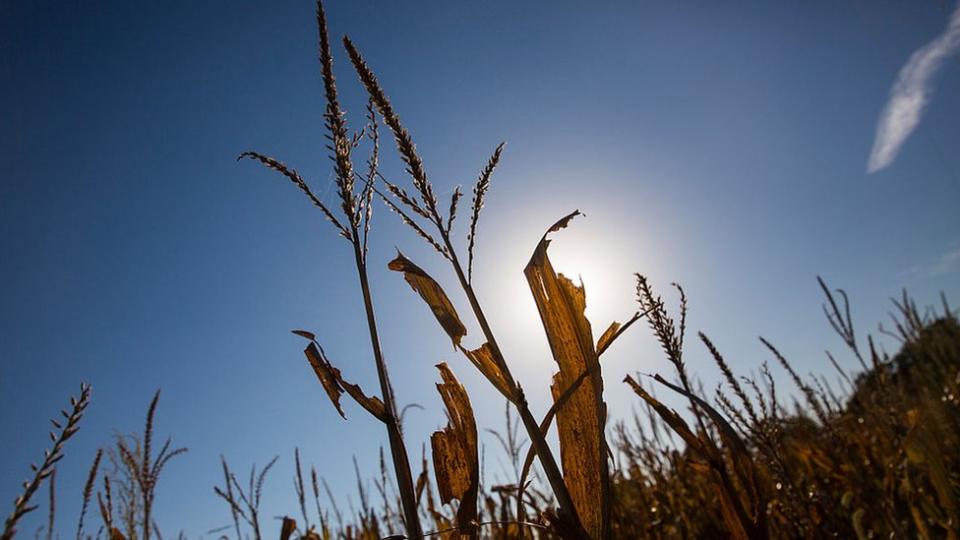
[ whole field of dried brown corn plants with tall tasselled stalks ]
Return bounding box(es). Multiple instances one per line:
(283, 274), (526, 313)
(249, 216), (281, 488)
(7, 4), (960, 540)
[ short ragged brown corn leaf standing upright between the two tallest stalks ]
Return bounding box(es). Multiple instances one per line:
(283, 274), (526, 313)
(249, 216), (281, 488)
(430, 364), (480, 538)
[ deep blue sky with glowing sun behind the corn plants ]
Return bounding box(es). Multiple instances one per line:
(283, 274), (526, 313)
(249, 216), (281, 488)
(0, 0), (960, 538)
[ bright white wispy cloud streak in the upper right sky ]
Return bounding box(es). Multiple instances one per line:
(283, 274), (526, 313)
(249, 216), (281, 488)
(867, 4), (960, 173)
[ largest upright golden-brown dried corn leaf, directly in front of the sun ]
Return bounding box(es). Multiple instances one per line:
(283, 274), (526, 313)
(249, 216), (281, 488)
(524, 212), (610, 538)
